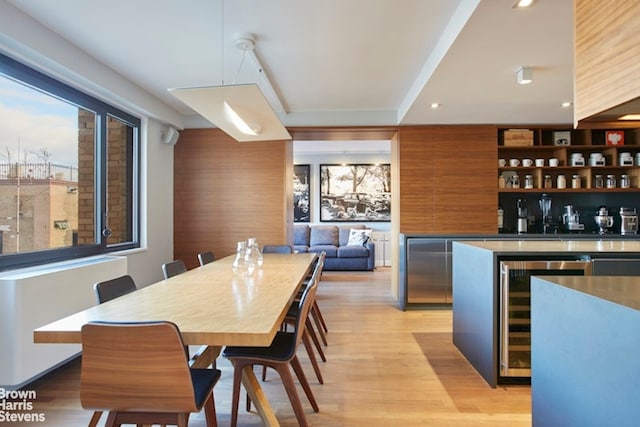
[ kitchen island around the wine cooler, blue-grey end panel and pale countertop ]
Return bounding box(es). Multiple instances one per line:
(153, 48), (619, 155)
(452, 239), (640, 387)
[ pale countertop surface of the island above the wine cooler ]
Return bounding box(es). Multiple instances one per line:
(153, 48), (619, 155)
(456, 240), (640, 253)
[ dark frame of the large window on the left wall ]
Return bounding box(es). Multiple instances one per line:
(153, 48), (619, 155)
(0, 53), (142, 271)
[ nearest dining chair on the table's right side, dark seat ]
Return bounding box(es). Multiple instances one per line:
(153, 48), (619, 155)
(223, 266), (320, 427)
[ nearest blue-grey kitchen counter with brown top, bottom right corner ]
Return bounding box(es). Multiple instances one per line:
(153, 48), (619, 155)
(531, 276), (640, 426)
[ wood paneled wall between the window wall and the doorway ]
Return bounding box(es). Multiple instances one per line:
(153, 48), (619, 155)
(170, 129), (293, 267)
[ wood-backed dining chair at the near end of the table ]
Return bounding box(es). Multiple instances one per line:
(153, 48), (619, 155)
(80, 321), (221, 427)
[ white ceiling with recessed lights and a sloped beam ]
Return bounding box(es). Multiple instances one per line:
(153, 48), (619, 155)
(4, 0), (573, 133)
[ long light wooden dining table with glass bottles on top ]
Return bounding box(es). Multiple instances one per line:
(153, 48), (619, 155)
(33, 253), (316, 426)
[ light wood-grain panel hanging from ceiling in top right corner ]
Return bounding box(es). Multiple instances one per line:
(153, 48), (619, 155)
(574, 0), (640, 123)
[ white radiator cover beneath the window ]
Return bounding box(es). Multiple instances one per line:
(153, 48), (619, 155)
(0, 256), (127, 390)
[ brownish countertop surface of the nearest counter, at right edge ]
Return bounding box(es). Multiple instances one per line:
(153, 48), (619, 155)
(538, 276), (640, 310)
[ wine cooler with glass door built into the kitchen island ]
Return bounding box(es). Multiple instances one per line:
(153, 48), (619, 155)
(499, 260), (591, 378)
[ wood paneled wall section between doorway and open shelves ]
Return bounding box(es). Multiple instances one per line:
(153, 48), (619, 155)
(398, 125), (498, 234)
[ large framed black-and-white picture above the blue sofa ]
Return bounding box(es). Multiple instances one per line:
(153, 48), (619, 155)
(320, 164), (391, 222)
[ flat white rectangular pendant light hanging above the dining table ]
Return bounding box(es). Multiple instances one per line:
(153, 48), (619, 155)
(169, 84), (291, 142)
